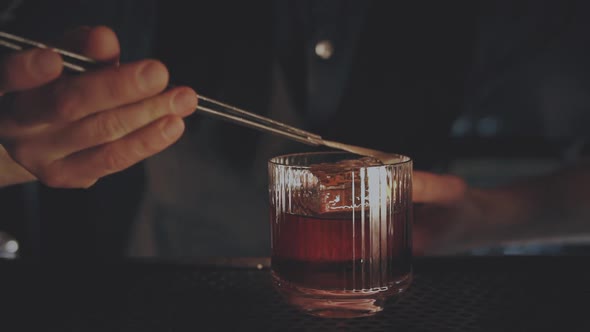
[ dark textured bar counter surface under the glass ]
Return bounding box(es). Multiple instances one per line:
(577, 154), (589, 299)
(0, 256), (590, 332)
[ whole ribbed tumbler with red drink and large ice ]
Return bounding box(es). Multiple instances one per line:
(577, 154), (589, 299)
(268, 152), (412, 317)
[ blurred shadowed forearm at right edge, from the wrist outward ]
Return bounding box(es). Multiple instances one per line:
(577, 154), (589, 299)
(471, 159), (590, 245)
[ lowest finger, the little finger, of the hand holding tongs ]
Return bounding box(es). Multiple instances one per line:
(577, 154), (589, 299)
(50, 115), (184, 188)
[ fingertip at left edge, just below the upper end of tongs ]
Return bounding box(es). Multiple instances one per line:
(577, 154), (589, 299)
(0, 49), (63, 93)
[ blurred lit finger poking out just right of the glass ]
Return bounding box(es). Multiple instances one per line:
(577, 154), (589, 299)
(412, 171), (467, 205)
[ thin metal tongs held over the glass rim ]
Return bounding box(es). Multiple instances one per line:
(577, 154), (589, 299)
(0, 31), (401, 163)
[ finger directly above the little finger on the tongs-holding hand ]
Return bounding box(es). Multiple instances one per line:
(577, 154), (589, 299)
(45, 88), (197, 159)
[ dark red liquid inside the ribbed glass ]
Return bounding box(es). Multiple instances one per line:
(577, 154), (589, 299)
(271, 211), (411, 291)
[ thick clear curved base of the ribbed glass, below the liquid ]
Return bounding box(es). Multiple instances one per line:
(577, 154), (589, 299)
(272, 272), (412, 318)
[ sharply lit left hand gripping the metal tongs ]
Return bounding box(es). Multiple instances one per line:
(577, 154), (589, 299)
(0, 27), (197, 188)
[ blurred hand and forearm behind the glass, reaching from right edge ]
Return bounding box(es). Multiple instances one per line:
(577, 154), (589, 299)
(414, 160), (590, 254)
